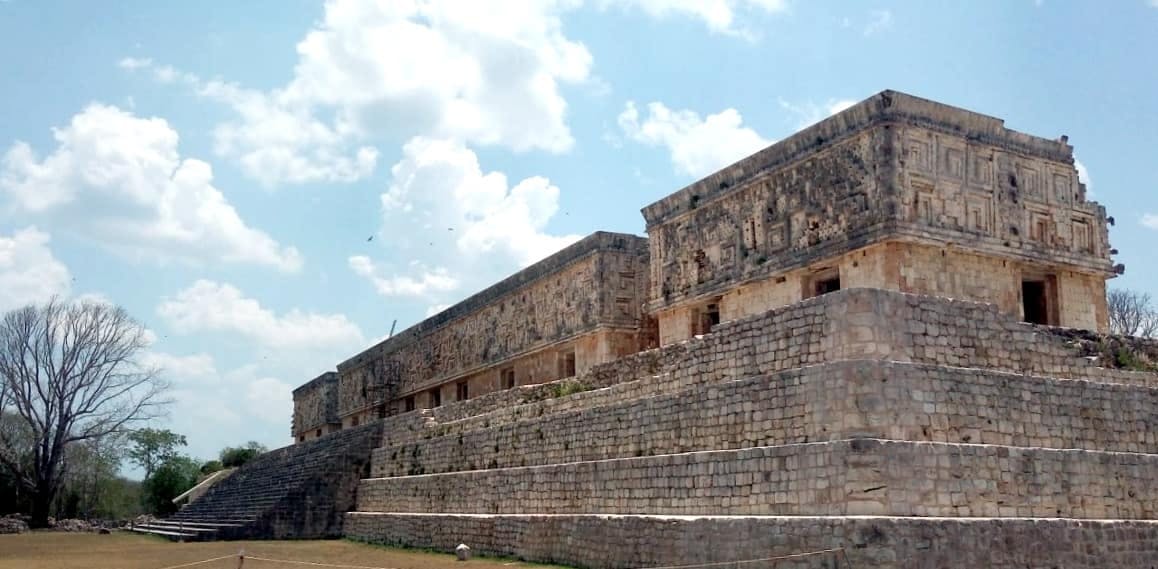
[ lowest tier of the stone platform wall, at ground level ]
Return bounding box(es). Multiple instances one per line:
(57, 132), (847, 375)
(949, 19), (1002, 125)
(346, 512), (1158, 569)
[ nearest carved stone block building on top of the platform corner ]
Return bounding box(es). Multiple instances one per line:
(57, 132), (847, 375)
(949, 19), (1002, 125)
(643, 92), (1113, 344)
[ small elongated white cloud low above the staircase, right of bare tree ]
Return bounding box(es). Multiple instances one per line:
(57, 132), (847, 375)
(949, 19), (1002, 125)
(157, 279), (365, 354)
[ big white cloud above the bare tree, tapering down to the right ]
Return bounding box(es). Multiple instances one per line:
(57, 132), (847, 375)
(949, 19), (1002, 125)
(0, 104), (302, 271)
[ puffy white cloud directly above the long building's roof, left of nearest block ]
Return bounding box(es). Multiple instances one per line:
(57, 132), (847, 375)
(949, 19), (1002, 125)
(349, 138), (579, 300)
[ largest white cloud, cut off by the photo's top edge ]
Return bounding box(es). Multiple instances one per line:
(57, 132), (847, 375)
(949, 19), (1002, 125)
(120, 0), (592, 185)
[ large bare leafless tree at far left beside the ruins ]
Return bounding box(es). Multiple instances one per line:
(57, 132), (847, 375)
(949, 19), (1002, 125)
(0, 299), (167, 527)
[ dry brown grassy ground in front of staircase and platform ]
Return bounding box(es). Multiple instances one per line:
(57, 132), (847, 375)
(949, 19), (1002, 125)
(0, 532), (560, 569)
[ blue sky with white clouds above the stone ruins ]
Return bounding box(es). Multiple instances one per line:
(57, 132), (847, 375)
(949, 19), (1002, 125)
(0, 0), (1158, 470)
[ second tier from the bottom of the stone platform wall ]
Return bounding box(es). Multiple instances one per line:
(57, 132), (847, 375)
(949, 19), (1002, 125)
(358, 439), (1158, 519)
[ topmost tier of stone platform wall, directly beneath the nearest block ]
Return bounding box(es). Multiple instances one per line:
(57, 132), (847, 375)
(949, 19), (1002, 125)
(384, 289), (1158, 437)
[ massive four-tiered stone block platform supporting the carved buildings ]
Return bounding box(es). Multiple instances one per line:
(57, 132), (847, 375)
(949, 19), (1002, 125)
(345, 290), (1158, 569)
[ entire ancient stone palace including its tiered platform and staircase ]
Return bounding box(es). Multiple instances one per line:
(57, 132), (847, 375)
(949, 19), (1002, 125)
(154, 92), (1158, 569)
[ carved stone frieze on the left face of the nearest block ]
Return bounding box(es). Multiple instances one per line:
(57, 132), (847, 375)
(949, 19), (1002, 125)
(647, 131), (892, 312)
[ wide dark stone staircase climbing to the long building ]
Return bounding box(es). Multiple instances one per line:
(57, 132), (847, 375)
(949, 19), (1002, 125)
(134, 423), (381, 541)
